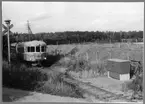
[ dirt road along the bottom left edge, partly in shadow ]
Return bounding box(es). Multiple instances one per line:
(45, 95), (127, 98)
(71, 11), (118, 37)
(3, 88), (88, 102)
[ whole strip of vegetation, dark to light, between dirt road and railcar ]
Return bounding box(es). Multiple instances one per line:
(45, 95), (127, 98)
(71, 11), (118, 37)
(3, 61), (83, 98)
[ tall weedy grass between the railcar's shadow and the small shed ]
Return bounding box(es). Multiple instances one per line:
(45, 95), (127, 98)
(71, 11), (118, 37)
(54, 56), (106, 78)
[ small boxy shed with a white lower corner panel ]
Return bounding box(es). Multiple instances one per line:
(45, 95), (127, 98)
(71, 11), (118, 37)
(107, 59), (130, 81)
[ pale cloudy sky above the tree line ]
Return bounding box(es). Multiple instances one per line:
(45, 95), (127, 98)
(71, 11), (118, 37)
(2, 2), (144, 33)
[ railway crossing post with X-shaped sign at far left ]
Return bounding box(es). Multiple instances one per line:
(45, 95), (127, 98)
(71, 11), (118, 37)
(3, 20), (13, 65)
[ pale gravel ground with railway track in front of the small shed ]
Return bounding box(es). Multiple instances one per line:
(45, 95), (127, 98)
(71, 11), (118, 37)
(63, 71), (142, 102)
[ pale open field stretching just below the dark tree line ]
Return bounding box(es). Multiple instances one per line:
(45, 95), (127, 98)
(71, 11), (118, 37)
(47, 43), (144, 62)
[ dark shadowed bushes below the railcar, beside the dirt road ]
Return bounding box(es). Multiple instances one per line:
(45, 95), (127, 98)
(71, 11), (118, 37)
(2, 61), (47, 90)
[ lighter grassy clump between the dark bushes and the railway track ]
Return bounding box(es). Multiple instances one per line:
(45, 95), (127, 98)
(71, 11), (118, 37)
(37, 70), (83, 98)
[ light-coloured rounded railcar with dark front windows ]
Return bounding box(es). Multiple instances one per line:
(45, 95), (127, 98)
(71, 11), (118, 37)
(12, 40), (47, 63)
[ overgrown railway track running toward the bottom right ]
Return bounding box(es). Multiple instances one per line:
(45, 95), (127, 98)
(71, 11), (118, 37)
(62, 76), (131, 102)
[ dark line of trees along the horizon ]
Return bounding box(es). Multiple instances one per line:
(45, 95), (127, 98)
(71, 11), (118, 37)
(10, 31), (143, 44)
